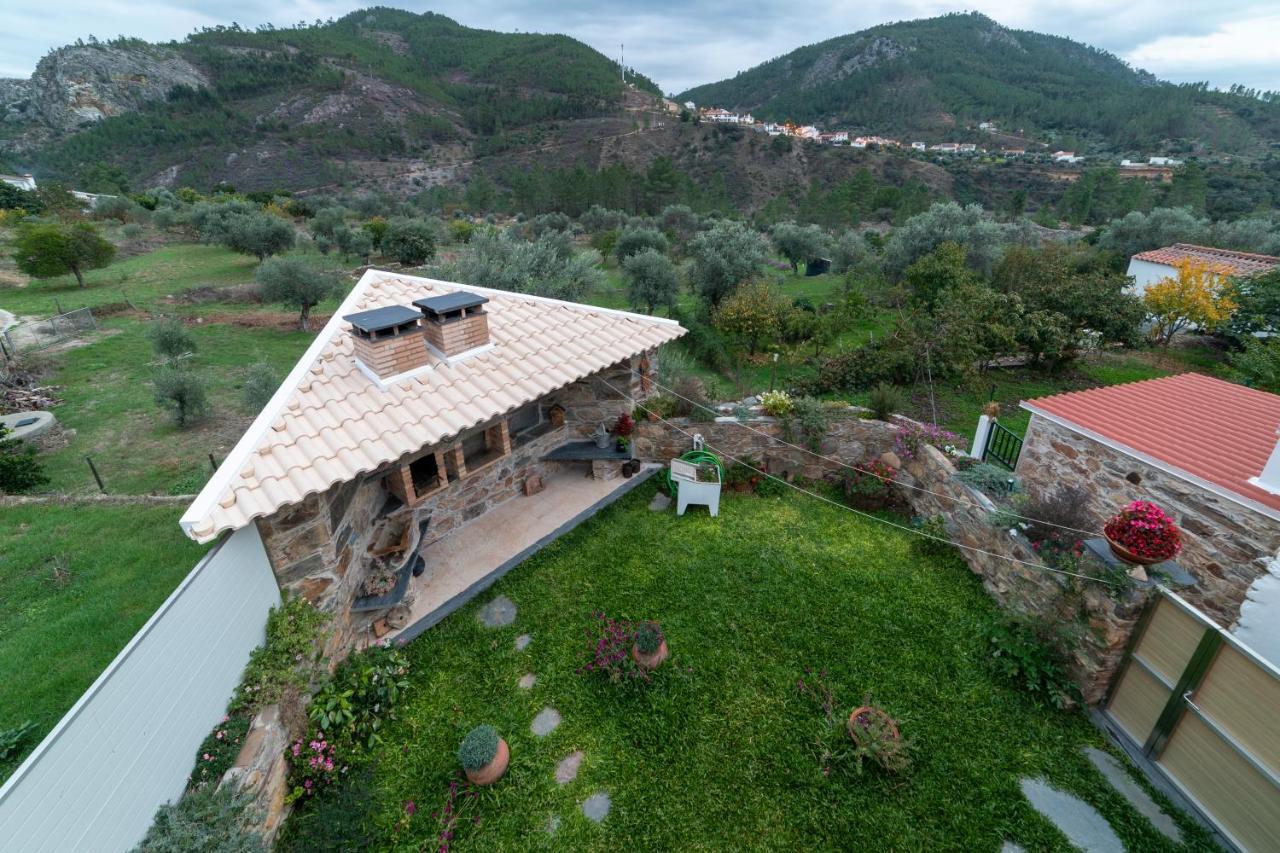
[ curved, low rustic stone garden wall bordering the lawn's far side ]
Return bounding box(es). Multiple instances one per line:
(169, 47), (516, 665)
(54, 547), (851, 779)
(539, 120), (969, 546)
(636, 409), (1151, 703)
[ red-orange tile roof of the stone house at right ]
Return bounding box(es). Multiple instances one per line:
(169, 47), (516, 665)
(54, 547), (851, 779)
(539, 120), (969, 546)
(1023, 373), (1280, 511)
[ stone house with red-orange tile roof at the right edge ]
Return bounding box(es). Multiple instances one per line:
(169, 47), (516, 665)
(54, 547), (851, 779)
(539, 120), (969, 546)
(1016, 373), (1280, 650)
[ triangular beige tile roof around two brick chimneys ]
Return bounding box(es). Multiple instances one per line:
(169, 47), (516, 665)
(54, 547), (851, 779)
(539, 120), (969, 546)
(182, 270), (685, 542)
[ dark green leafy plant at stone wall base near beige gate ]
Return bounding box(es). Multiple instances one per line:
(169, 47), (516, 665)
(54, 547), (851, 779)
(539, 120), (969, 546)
(983, 613), (1080, 708)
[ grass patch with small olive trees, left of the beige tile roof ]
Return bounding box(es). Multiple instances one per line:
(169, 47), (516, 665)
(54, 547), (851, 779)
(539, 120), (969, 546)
(35, 318), (312, 494)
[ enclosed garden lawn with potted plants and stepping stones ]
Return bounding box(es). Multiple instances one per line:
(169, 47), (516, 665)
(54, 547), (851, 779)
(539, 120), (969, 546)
(284, 484), (1204, 850)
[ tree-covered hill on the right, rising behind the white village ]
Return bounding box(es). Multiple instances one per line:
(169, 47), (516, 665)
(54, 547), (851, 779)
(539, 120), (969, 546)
(678, 13), (1280, 154)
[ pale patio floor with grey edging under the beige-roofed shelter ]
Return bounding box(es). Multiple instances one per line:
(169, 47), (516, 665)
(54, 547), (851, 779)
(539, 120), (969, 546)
(387, 465), (662, 642)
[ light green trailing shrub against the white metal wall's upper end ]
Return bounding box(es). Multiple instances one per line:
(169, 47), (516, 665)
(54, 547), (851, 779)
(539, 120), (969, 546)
(229, 598), (329, 715)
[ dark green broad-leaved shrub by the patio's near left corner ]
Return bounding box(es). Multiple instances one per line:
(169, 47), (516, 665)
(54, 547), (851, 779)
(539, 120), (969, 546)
(307, 646), (408, 749)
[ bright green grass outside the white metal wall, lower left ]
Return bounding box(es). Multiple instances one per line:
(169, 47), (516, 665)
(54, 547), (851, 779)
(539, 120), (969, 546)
(0, 506), (205, 781)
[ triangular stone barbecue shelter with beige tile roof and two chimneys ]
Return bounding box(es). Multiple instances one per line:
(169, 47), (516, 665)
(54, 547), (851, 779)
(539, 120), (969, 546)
(182, 270), (685, 654)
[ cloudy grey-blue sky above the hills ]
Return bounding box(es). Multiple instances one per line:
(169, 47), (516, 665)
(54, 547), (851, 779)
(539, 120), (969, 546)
(0, 0), (1280, 91)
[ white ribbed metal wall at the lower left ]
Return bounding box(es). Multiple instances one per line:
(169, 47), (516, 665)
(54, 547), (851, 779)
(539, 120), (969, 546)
(0, 525), (280, 853)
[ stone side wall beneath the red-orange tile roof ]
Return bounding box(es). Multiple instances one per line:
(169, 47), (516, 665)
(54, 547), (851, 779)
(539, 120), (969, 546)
(1018, 415), (1280, 628)
